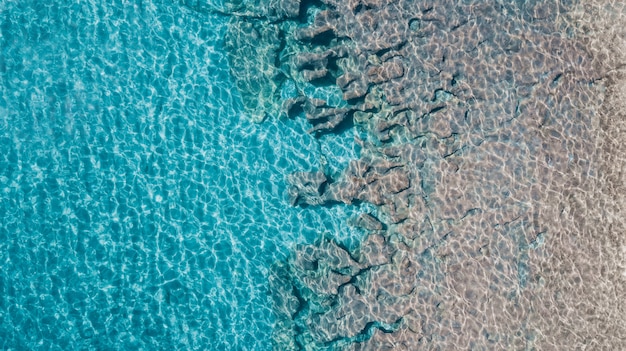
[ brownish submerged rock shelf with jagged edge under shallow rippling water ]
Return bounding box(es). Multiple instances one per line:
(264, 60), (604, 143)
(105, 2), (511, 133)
(219, 0), (626, 350)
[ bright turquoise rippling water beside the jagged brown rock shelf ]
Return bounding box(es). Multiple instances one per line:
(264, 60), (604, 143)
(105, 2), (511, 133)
(0, 0), (362, 350)
